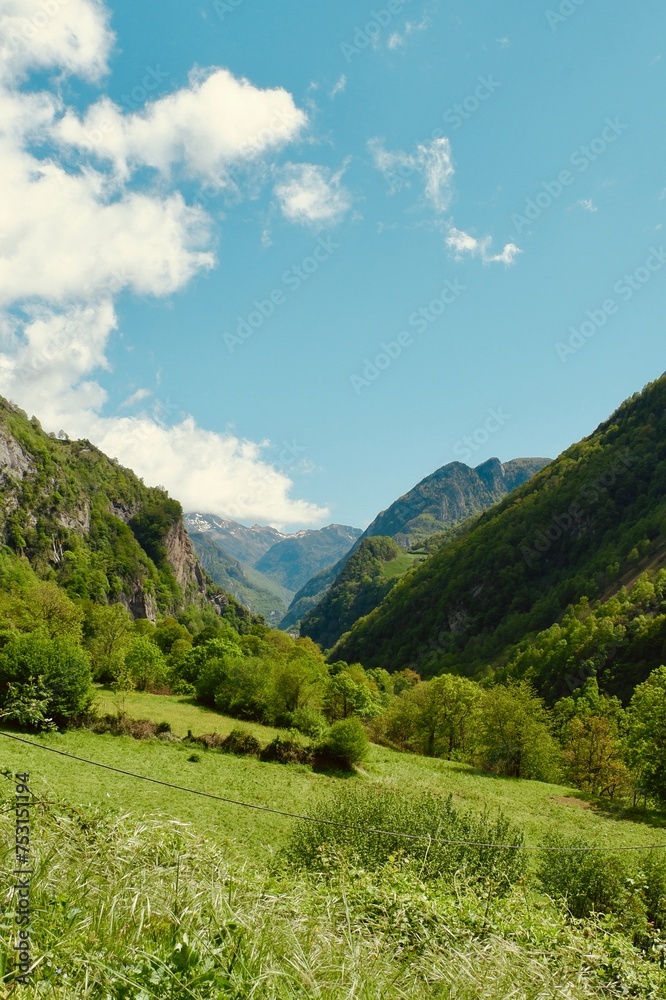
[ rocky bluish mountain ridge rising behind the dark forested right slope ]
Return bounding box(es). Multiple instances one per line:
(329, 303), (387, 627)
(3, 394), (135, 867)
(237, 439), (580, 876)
(280, 458), (550, 628)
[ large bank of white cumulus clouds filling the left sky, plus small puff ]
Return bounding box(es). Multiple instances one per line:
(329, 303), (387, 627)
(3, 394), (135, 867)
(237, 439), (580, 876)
(0, 0), (328, 526)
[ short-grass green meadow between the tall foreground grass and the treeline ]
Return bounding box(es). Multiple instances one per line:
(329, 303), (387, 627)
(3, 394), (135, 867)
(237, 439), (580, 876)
(0, 691), (666, 855)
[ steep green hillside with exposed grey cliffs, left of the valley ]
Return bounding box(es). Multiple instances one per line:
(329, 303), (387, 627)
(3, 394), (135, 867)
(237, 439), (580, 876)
(0, 399), (248, 618)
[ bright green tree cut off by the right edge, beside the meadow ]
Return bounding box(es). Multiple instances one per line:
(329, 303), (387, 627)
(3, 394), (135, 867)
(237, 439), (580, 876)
(626, 666), (666, 804)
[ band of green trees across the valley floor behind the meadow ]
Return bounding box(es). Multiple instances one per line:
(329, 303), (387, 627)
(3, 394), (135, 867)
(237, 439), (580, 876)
(0, 556), (666, 803)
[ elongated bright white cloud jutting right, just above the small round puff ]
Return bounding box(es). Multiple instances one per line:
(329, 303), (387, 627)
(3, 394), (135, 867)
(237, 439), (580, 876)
(55, 69), (307, 180)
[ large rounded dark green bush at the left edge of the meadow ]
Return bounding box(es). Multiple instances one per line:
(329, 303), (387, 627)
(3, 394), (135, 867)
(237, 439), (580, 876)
(0, 633), (92, 726)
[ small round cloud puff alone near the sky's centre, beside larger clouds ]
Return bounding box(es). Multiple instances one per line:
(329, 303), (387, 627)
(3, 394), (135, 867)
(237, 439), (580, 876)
(275, 163), (352, 225)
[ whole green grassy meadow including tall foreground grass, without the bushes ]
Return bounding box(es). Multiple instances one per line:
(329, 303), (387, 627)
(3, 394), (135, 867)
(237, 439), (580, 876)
(0, 691), (666, 1000)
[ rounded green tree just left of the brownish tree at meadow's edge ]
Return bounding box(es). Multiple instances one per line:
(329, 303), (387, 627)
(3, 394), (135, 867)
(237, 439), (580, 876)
(481, 681), (560, 781)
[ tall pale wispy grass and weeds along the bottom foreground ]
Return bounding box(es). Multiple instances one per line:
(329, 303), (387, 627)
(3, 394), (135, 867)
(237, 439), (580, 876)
(0, 802), (666, 1000)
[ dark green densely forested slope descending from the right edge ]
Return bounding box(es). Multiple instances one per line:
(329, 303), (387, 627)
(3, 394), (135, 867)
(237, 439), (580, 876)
(331, 377), (666, 692)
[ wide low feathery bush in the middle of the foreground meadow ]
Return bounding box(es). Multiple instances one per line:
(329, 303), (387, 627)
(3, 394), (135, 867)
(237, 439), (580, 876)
(284, 782), (528, 894)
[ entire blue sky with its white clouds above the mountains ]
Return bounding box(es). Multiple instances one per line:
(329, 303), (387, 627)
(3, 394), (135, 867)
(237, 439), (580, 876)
(0, 0), (666, 530)
